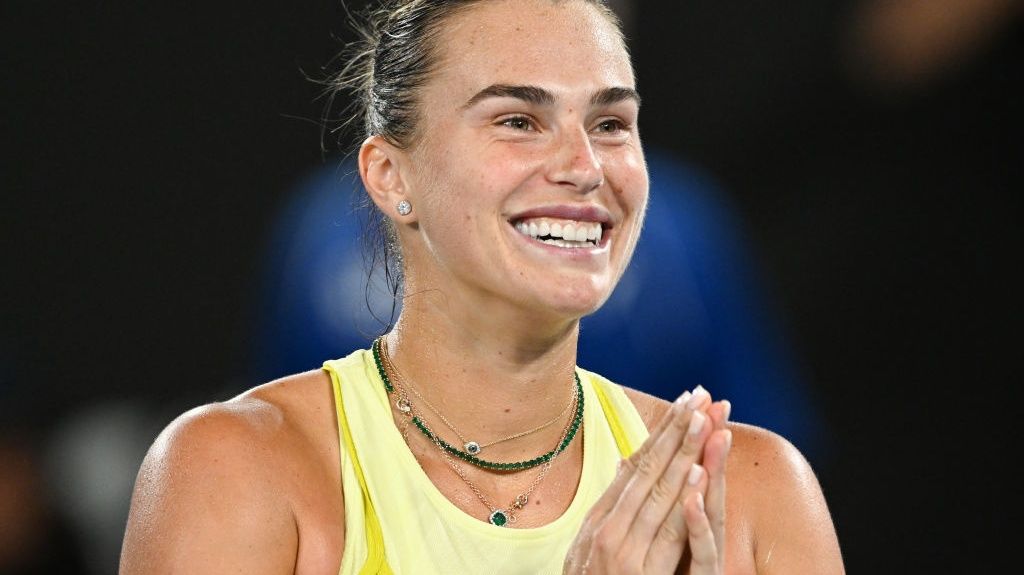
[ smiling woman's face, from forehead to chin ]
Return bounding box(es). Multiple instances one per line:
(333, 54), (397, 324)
(399, 0), (647, 318)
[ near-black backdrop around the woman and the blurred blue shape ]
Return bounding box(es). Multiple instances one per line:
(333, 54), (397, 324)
(0, 0), (1024, 573)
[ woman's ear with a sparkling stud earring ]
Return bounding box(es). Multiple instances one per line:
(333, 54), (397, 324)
(359, 136), (416, 223)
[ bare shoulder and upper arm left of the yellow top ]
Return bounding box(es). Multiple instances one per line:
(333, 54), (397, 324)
(121, 372), (335, 574)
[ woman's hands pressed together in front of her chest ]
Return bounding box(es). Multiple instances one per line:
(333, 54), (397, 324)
(563, 387), (731, 575)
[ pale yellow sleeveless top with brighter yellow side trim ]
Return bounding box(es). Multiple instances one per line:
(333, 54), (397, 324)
(324, 350), (647, 575)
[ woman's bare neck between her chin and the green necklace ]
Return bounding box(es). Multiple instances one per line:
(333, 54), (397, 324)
(385, 293), (579, 453)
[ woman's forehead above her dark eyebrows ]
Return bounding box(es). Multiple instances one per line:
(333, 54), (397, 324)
(425, 0), (634, 96)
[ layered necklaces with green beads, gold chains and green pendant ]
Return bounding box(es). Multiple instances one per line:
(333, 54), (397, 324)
(371, 337), (584, 527)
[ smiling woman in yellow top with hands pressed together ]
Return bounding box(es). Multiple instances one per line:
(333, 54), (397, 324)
(121, 0), (843, 574)
